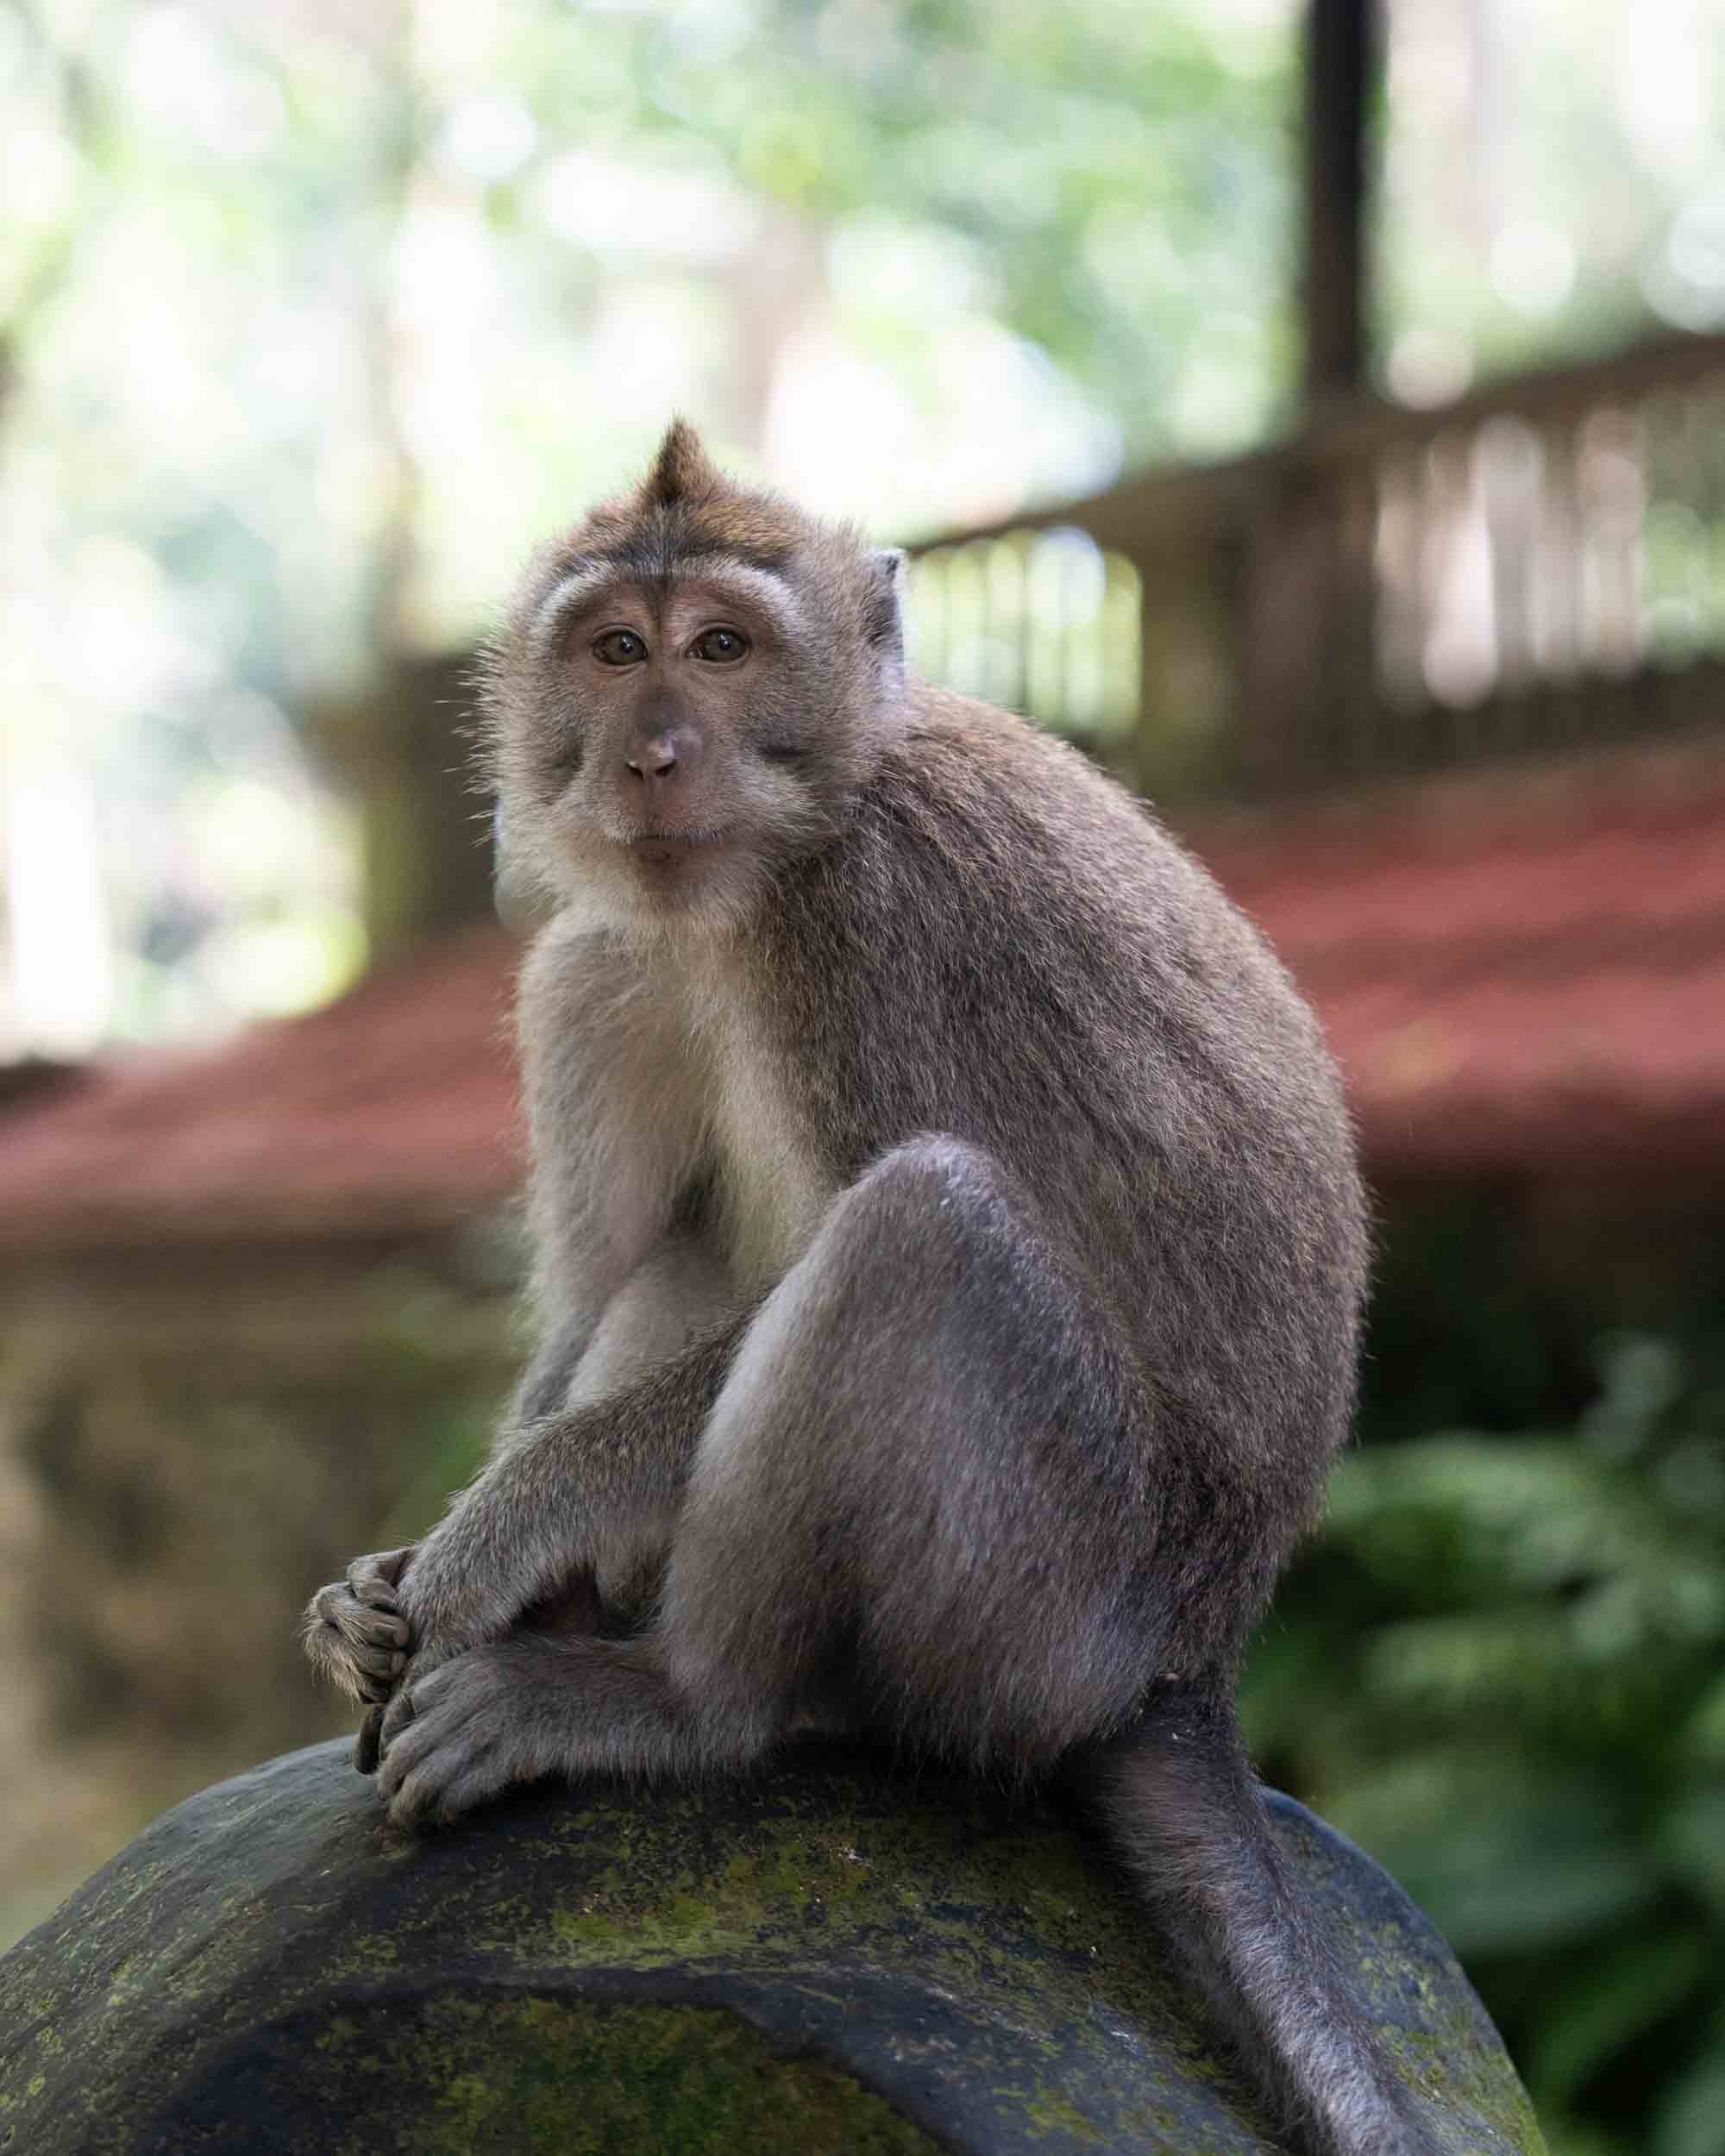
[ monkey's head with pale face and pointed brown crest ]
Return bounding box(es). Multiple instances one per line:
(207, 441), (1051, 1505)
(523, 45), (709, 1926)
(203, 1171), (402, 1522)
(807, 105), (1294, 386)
(490, 429), (901, 925)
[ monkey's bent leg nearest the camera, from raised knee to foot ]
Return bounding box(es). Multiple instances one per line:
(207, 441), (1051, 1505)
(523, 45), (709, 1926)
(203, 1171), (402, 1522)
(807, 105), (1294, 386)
(382, 1141), (1160, 1820)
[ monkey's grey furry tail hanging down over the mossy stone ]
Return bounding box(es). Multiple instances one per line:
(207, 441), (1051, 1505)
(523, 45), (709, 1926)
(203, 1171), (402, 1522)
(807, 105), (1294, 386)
(1087, 1686), (1440, 2156)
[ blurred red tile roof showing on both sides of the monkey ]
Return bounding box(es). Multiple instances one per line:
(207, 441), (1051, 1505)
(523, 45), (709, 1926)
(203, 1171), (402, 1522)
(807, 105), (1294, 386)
(0, 753), (1725, 1253)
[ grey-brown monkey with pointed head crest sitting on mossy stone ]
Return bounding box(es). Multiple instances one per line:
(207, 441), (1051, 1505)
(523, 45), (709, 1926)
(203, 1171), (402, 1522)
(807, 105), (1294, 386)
(306, 421), (1439, 2156)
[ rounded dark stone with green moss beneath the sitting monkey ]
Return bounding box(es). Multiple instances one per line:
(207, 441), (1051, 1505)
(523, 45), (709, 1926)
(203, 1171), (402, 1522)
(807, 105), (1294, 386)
(0, 1745), (1542, 2156)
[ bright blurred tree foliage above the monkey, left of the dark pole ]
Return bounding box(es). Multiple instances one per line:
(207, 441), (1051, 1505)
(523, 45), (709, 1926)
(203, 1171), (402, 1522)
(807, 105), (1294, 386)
(0, 0), (1298, 1046)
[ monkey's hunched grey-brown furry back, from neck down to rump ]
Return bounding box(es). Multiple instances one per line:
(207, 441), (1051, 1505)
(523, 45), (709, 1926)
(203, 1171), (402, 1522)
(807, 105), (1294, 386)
(762, 690), (1367, 1624)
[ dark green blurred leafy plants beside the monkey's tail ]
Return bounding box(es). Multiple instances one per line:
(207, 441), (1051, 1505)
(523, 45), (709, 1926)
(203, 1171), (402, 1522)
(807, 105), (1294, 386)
(1246, 1298), (1725, 2156)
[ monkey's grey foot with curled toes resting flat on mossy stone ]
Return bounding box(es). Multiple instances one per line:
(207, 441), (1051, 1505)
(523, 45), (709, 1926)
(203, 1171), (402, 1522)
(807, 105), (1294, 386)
(378, 1634), (716, 1827)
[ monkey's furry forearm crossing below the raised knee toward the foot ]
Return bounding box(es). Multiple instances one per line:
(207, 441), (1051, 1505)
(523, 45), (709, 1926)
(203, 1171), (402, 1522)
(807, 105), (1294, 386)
(397, 1313), (753, 1669)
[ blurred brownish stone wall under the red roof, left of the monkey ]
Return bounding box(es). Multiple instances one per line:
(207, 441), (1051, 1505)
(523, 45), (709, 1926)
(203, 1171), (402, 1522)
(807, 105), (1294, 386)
(0, 1225), (522, 1945)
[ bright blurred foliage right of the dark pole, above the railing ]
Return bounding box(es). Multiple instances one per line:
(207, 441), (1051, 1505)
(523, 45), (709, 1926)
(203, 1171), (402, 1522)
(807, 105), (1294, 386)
(1376, 0), (1725, 404)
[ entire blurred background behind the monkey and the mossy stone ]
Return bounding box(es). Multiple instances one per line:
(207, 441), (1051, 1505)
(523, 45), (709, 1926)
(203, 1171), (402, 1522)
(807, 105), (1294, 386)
(0, 0), (1725, 2156)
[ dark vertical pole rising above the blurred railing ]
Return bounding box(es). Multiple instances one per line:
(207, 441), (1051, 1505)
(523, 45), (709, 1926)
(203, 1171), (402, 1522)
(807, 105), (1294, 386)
(1302, 0), (1378, 405)
